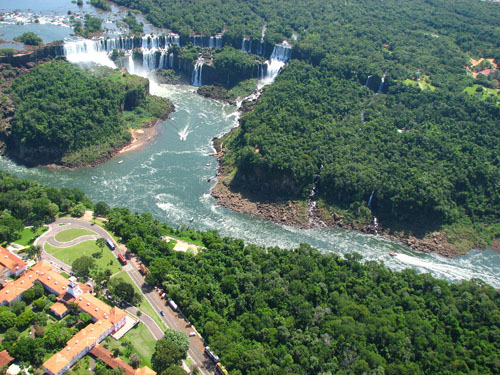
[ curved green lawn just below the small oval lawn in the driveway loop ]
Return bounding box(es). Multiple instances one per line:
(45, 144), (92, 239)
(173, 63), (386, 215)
(45, 241), (122, 274)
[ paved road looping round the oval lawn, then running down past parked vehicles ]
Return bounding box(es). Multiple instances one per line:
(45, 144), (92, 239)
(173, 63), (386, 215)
(35, 218), (214, 375)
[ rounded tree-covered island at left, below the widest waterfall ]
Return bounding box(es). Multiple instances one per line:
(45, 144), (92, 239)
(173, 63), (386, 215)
(2, 60), (173, 167)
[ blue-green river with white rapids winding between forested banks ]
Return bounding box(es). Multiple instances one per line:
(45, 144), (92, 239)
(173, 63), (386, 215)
(0, 0), (500, 288)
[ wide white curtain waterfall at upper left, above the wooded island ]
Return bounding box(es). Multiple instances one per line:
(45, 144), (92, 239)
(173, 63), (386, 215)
(64, 34), (180, 75)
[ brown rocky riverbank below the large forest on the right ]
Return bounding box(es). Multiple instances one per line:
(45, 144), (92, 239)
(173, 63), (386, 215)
(211, 151), (492, 258)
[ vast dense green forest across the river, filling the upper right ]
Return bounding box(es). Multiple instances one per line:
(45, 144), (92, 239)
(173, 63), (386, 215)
(109, 0), (500, 253)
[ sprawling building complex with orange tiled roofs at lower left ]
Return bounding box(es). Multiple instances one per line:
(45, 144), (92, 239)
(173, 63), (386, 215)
(0, 262), (156, 375)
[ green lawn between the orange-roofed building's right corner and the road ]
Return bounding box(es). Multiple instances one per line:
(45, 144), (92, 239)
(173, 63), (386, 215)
(105, 322), (156, 367)
